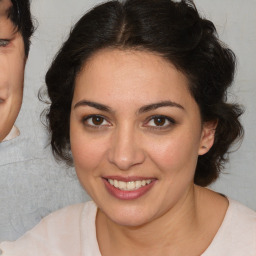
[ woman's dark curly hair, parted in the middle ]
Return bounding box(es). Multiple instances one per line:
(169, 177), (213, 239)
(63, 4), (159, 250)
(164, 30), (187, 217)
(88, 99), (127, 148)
(46, 0), (243, 186)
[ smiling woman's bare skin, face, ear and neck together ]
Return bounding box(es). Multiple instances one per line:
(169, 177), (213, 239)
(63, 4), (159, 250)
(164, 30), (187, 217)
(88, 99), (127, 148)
(70, 49), (228, 256)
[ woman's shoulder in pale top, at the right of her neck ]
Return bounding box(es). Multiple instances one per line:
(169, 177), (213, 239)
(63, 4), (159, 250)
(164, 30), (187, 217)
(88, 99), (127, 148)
(203, 199), (256, 256)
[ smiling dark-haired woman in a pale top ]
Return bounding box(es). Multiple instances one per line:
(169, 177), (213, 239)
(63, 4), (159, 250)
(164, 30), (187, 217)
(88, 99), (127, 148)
(0, 0), (256, 256)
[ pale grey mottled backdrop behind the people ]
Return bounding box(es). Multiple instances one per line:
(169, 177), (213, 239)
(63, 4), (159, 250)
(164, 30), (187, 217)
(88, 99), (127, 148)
(0, 0), (256, 241)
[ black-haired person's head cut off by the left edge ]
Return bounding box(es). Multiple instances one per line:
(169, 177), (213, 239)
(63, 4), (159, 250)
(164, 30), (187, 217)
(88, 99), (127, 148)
(0, 0), (33, 142)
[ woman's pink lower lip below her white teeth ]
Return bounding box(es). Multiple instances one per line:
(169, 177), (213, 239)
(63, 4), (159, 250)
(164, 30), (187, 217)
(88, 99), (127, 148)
(103, 179), (156, 200)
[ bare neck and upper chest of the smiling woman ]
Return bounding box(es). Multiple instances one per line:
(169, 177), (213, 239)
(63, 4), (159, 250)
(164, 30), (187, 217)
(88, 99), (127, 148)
(96, 185), (226, 256)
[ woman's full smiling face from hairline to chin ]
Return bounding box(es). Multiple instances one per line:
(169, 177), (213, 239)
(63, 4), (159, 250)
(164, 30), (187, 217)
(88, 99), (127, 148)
(70, 50), (212, 226)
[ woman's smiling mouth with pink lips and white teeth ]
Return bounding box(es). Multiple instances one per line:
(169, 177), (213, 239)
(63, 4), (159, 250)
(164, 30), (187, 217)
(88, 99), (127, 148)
(103, 177), (156, 200)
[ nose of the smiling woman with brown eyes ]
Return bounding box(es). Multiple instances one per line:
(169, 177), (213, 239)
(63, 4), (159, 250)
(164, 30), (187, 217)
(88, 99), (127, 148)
(108, 125), (145, 170)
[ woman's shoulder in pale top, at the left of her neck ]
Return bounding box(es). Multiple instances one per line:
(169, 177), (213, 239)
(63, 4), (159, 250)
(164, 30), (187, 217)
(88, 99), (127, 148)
(0, 201), (97, 256)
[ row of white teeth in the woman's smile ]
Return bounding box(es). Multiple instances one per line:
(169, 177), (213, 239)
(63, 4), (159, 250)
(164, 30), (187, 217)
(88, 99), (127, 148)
(108, 179), (152, 191)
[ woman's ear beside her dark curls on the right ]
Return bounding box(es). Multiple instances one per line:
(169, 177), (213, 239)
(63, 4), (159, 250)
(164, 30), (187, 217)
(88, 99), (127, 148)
(198, 120), (218, 155)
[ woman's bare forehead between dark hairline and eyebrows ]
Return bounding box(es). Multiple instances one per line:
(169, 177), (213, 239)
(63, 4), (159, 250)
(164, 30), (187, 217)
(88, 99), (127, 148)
(74, 49), (193, 109)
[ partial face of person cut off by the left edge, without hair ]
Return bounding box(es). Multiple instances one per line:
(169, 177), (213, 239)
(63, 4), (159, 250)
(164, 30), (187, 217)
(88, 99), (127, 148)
(0, 0), (26, 142)
